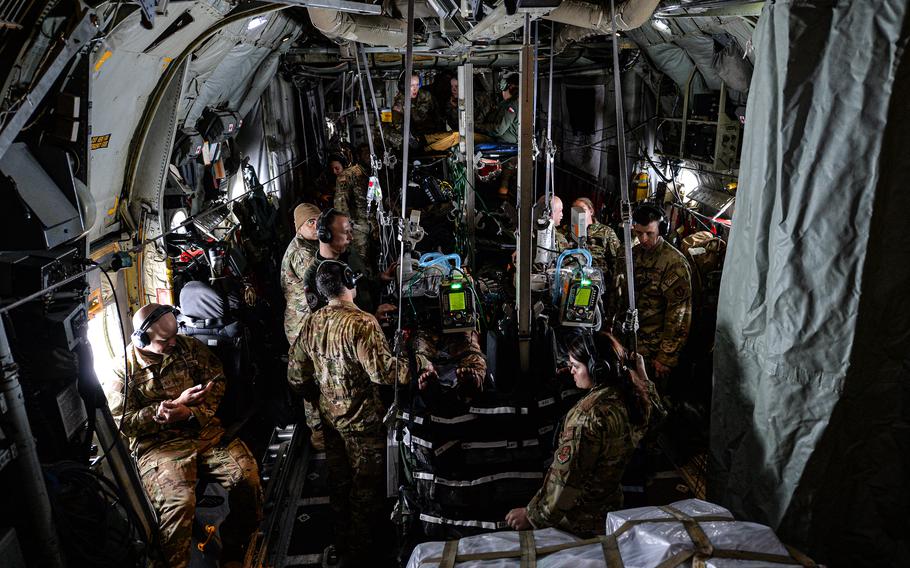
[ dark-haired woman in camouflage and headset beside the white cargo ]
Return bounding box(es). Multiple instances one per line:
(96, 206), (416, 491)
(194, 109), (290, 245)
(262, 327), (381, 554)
(506, 336), (664, 538)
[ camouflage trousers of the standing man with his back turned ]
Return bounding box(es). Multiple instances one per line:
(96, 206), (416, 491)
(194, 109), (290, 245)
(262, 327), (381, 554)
(323, 427), (385, 566)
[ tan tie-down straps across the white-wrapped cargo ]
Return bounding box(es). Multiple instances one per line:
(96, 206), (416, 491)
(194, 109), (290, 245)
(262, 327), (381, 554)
(420, 506), (817, 568)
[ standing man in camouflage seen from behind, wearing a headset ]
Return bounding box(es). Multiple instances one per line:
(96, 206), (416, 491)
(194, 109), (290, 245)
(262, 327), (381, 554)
(288, 262), (433, 566)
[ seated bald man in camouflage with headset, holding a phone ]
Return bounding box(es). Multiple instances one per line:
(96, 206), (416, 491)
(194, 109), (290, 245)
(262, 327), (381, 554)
(108, 304), (262, 568)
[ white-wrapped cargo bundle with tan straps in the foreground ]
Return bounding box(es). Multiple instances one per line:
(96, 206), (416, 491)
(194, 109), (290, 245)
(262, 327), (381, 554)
(407, 499), (815, 568)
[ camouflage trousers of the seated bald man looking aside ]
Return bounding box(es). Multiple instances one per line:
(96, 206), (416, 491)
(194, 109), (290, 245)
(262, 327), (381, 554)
(139, 439), (262, 568)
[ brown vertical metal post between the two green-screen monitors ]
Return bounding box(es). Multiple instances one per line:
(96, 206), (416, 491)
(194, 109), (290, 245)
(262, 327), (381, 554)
(516, 14), (535, 373)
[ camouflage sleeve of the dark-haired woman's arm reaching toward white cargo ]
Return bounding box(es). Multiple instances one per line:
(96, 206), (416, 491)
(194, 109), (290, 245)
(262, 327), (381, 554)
(528, 411), (622, 529)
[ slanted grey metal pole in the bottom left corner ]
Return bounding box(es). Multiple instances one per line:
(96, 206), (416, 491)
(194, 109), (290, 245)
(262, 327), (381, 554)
(0, 319), (64, 568)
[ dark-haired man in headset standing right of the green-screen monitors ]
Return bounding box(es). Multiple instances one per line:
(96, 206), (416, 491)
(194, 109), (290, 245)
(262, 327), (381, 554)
(620, 204), (692, 386)
